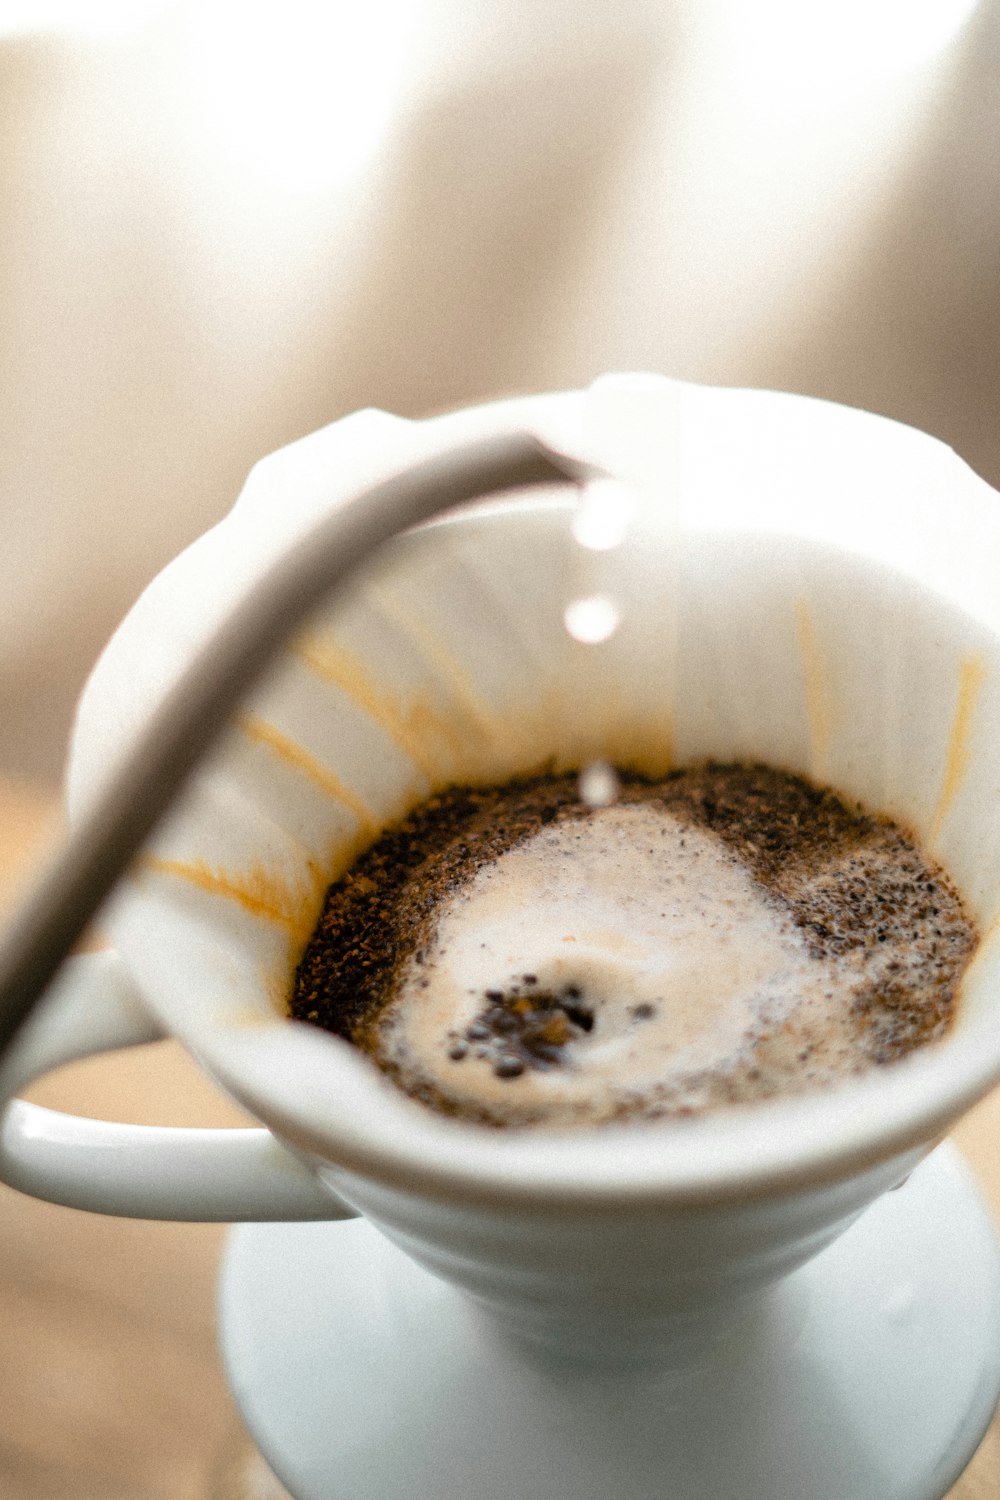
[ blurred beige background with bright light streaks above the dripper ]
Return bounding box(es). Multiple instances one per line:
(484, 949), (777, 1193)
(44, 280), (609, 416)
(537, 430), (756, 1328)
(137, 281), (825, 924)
(0, 0), (1000, 782)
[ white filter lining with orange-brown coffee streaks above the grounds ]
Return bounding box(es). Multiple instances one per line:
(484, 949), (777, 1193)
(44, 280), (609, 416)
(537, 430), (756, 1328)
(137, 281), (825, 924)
(69, 378), (1000, 1194)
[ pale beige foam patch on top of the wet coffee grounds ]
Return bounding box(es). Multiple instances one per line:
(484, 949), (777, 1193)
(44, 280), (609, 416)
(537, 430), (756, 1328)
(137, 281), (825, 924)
(379, 806), (881, 1122)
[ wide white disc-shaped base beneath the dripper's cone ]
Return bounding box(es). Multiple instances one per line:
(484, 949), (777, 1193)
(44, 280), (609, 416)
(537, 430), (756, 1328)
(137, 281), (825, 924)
(220, 1146), (1000, 1500)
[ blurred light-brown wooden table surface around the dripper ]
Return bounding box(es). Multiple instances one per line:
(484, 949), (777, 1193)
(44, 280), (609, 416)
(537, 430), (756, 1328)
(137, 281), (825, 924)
(0, 777), (1000, 1500)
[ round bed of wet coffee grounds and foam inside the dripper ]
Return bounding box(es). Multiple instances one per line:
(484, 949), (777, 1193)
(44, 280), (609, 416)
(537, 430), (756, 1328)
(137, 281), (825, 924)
(291, 765), (978, 1127)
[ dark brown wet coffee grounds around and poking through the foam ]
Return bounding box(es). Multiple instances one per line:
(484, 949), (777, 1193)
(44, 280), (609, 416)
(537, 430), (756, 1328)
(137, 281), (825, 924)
(291, 764), (978, 1124)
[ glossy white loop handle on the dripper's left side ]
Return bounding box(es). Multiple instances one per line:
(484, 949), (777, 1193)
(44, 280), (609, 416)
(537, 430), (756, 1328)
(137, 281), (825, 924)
(0, 951), (355, 1223)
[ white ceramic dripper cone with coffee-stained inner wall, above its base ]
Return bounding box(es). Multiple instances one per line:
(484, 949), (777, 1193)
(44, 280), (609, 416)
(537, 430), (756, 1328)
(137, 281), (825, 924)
(4, 372), (1000, 1494)
